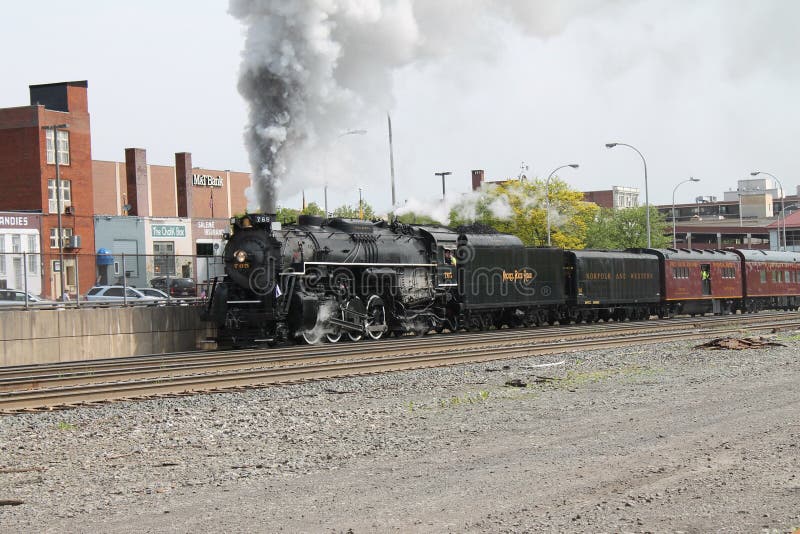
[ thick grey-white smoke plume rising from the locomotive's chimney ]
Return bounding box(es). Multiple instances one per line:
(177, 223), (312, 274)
(225, 0), (601, 216)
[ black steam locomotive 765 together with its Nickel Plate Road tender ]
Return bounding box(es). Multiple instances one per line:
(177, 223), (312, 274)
(208, 214), (564, 345)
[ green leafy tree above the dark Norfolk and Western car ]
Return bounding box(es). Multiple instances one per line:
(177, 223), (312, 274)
(586, 206), (672, 250)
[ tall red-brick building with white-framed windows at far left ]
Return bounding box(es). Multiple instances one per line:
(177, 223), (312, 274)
(0, 81), (94, 297)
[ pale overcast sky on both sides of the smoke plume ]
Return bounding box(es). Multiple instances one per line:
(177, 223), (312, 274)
(0, 0), (800, 215)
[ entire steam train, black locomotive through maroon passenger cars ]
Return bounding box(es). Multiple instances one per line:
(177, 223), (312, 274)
(207, 214), (800, 345)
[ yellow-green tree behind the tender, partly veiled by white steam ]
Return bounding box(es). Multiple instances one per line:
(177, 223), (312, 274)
(450, 178), (598, 249)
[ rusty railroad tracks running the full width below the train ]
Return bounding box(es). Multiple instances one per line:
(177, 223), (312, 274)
(0, 313), (800, 414)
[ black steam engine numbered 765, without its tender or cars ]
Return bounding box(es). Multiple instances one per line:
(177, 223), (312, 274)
(209, 214), (457, 345)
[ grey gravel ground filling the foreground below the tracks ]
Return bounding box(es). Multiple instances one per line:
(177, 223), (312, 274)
(0, 334), (800, 532)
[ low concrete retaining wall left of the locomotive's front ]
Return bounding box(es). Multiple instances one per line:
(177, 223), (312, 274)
(0, 306), (208, 366)
